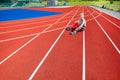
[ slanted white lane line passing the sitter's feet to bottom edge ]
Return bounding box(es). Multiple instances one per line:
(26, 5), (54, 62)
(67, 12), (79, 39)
(28, 9), (79, 80)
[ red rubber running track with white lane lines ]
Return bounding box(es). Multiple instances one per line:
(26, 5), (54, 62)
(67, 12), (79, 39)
(0, 6), (120, 80)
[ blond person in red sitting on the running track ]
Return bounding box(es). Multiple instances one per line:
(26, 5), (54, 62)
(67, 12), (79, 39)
(66, 13), (86, 35)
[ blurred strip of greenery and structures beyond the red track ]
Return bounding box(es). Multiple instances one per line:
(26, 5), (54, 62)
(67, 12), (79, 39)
(0, 0), (120, 12)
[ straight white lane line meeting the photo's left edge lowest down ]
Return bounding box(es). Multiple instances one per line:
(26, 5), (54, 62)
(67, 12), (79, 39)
(0, 11), (71, 64)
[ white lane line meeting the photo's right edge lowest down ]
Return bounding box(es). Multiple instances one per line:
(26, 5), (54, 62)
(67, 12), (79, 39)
(88, 6), (120, 54)
